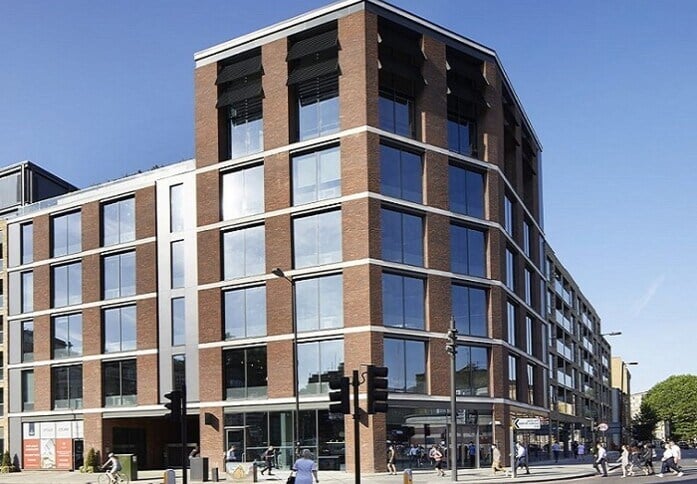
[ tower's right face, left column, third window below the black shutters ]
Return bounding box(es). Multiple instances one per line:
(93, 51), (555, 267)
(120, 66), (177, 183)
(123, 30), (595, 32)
(382, 273), (426, 329)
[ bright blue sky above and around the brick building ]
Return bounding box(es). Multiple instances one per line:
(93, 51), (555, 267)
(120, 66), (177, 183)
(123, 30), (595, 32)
(0, 0), (697, 391)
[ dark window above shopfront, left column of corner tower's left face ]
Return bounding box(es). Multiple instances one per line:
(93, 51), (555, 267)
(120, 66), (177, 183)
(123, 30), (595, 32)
(223, 346), (268, 400)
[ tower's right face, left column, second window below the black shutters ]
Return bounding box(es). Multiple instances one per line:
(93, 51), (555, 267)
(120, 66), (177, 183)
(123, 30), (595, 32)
(382, 208), (424, 266)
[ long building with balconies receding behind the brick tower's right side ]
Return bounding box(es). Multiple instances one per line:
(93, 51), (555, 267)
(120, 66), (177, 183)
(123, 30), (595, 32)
(546, 246), (612, 451)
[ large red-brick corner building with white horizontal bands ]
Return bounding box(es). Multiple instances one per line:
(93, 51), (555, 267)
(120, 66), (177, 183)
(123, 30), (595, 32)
(5, 0), (609, 472)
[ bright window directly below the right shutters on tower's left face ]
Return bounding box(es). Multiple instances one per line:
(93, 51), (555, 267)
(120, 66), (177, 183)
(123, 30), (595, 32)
(293, 146), (341, 205)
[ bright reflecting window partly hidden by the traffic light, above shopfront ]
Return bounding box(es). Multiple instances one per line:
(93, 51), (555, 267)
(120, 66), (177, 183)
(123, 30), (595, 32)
(298, 340), (344, 395)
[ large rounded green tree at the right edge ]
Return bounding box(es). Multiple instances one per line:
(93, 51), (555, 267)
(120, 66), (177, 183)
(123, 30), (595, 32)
(644, 375), (697, 439)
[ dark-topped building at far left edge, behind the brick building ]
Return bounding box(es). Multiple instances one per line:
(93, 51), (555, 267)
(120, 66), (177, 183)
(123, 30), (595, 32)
(0, 161), (76, 452)
